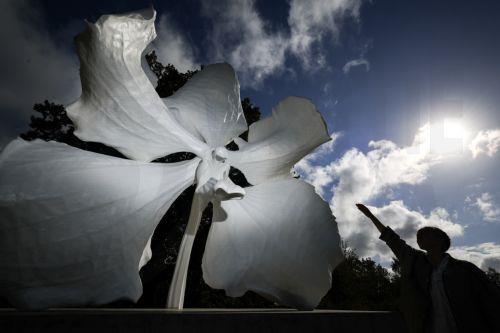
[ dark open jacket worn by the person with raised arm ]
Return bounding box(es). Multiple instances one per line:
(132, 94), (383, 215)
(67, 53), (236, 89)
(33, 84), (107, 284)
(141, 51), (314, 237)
(380, 227), (500, 333)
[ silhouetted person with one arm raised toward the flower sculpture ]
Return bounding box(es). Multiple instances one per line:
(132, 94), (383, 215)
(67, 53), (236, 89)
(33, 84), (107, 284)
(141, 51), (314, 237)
(356, 204), (500, 333)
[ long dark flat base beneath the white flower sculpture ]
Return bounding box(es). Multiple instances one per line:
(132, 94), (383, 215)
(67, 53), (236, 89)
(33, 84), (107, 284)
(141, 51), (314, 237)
(0, 309), (405, 333)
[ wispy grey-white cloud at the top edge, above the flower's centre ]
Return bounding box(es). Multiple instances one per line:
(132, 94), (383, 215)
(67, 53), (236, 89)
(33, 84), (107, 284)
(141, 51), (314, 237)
(203, 0), (361, 87)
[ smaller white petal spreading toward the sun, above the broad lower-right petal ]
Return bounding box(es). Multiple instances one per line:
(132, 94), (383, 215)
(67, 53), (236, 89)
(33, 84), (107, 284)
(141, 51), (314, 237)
(228, 97), (330, 185)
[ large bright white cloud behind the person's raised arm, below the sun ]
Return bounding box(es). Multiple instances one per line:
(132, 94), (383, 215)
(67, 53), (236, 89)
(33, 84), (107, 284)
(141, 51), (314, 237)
(298, 124), (463, 261)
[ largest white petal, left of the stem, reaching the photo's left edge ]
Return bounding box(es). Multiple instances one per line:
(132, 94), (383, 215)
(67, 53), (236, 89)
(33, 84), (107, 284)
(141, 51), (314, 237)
(0, 139), (199, 308)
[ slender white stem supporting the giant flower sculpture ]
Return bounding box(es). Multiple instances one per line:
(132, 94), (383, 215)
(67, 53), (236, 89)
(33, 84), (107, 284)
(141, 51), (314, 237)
(167, 192), (206, 309)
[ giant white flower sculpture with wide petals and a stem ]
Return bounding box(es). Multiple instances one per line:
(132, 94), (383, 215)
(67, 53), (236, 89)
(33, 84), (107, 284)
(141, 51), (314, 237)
(0, 9), (342, 308)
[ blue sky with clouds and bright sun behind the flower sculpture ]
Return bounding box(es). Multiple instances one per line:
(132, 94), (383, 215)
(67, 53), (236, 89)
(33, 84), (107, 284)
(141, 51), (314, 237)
(0, 0), (500, 269)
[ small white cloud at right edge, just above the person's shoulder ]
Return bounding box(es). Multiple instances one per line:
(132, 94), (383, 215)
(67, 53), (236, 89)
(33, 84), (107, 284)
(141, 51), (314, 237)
(449, 242), (500, 272)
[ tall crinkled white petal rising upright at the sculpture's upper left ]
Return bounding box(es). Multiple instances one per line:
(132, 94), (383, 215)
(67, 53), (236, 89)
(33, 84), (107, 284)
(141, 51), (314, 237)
(67, 9), (205, 161)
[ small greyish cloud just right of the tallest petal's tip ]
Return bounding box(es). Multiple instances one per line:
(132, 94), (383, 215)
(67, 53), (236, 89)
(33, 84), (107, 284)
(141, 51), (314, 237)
(153, 13), (199, 72)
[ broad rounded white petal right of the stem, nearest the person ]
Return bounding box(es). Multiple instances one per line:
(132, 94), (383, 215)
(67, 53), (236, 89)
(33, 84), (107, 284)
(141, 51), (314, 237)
(203, 179), (342, 308)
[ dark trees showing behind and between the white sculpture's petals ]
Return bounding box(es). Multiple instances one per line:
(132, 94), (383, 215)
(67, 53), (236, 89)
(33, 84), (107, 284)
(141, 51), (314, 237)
(5, 51), (500, 310)
